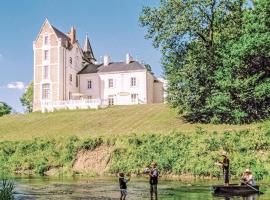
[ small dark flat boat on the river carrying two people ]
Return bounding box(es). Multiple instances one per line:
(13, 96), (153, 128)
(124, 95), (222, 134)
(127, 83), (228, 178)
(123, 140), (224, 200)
(212, 184), (260, 196)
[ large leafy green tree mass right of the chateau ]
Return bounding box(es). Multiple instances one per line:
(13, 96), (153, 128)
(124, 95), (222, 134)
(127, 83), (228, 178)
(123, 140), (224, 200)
(140, 0), (270, 123)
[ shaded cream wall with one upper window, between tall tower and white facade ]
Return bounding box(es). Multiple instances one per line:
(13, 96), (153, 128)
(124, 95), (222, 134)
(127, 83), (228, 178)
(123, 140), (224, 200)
(79, 73), (101, 99)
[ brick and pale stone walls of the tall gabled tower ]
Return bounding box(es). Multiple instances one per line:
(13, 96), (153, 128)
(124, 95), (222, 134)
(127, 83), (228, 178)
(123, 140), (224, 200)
(33, 21), (82, 111)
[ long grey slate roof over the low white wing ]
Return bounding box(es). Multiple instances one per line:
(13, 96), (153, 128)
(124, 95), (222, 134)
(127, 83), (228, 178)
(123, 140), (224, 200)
(78, 61), (146, 74)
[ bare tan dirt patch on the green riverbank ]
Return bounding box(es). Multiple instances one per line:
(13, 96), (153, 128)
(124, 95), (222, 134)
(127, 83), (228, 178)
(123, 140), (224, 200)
(73, 146), (112, 175)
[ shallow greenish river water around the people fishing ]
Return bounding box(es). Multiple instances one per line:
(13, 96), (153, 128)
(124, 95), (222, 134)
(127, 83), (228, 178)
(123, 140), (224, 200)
(10, 177), (270, 200)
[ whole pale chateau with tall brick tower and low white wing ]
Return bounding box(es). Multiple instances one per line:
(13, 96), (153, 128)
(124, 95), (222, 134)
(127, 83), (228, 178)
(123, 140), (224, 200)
(33, 19), (165, 112)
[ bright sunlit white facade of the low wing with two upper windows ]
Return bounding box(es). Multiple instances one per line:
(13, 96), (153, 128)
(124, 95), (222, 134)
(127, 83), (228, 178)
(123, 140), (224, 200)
(99, 70), (147, 105)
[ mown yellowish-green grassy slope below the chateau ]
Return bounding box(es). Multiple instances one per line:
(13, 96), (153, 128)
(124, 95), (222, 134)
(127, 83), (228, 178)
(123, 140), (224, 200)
(0, 104), (260, 141)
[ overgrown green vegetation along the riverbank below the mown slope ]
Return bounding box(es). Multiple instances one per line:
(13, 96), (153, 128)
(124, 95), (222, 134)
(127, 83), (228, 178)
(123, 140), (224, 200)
(0, 129), (270, 179)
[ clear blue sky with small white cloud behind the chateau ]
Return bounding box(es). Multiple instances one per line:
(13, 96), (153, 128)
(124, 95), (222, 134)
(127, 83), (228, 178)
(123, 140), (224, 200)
(0, 0), (163, 112)
